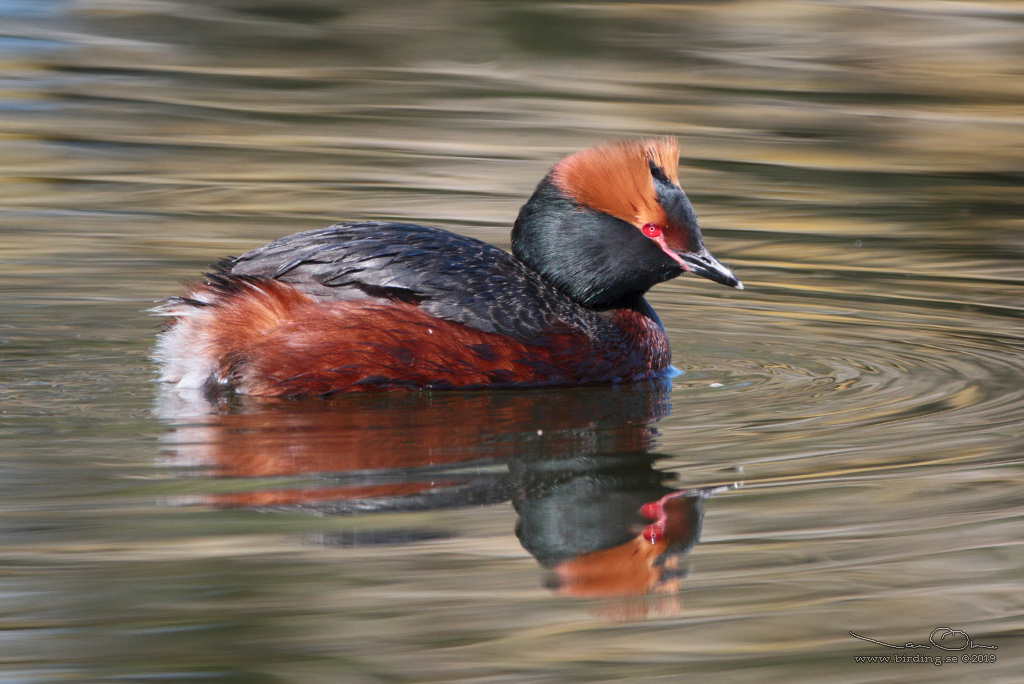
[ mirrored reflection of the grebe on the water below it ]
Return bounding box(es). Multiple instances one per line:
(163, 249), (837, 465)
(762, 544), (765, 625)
(157, 379), (718, 617)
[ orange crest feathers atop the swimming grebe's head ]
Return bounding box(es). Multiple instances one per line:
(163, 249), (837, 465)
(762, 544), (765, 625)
(551, 137), (679, 227)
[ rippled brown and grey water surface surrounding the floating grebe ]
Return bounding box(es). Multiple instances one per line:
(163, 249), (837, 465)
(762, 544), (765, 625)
(0, 0), (1024, 682)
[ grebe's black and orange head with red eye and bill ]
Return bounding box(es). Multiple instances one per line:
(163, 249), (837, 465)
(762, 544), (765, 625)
(512, 138), (743, 309)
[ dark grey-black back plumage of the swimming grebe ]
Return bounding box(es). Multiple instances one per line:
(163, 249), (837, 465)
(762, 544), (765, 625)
(226, 222), (607, 341)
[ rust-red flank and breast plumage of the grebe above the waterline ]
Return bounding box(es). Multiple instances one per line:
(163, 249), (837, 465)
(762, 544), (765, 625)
(159, 280), (669, 396)
